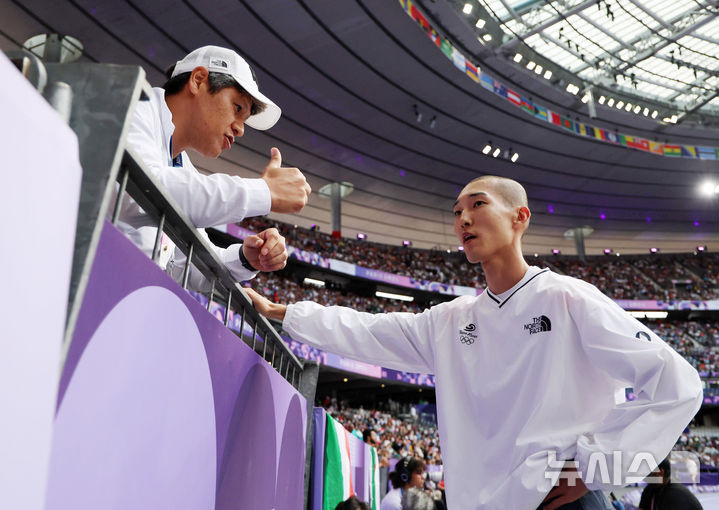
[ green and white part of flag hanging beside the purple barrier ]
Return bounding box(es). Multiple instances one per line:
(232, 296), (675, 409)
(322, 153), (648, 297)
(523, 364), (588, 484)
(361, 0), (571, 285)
(322, 414), (354, 510)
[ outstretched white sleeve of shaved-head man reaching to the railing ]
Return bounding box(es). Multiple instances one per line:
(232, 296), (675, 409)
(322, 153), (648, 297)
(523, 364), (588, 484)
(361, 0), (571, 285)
(282, 301), (441, 374)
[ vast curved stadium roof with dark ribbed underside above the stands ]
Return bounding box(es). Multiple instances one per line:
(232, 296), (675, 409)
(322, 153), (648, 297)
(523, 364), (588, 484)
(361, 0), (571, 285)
(0, 0), (719, 254)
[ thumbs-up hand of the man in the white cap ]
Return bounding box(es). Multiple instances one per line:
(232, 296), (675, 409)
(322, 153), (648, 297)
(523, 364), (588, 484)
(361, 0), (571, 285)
(262, 147), (312, 213)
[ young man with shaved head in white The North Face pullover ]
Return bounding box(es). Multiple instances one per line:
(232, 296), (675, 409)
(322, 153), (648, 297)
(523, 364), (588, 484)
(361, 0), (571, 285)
(250, 176), (702, 510)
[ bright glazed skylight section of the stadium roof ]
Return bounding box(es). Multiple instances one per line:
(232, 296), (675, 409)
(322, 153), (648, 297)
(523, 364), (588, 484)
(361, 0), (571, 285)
(462, 0), (719, 119)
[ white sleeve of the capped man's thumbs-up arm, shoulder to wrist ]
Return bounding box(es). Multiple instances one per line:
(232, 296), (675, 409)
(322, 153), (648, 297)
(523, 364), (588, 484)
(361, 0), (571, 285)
(127, 95), (271, 228)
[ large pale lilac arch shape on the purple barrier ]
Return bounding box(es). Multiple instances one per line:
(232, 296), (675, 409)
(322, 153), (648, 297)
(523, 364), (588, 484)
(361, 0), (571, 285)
(46, 287), (217, 510)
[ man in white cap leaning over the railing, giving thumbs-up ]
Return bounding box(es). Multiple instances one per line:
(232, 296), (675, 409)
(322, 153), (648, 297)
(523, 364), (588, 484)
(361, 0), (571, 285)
(120, 46), (310, 288)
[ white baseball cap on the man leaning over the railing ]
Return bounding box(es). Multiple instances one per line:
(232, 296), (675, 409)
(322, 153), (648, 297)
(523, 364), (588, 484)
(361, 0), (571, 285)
(171, 46), (282, 131)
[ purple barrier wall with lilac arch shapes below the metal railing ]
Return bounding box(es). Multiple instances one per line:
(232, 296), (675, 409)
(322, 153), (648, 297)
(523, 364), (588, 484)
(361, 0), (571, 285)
(46, 224), (307, 510)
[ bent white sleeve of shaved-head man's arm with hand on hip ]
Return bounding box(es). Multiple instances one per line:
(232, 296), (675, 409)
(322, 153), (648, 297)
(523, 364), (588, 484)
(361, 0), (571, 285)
(566, 282), (702, 490)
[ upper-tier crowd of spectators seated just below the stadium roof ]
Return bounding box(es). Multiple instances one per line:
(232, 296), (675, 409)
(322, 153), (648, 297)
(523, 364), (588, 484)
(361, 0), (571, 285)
(242, 218), (719, 301)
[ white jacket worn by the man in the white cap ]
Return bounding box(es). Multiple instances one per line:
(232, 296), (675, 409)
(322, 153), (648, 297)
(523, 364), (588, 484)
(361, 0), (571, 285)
(116, 88), (271, 290)
